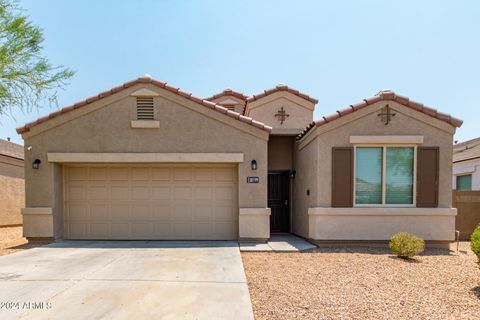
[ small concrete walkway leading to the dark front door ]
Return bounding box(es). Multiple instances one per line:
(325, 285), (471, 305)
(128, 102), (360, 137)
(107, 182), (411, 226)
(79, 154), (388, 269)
(240, 234), (317, 252)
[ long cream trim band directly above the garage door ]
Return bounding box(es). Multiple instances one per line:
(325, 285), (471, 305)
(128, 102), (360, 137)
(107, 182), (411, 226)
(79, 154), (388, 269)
(47, 152), (244, 163)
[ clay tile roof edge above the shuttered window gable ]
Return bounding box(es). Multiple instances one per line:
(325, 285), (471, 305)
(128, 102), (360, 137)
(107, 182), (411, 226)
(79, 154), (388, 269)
(297, 90), (463, 140)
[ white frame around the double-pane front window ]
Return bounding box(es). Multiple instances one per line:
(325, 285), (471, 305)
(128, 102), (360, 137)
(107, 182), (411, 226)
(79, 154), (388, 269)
(353, 144), (417, 208)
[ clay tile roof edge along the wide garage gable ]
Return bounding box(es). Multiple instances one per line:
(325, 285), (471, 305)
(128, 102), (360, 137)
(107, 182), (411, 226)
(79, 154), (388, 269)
(17, 75), (272, 134)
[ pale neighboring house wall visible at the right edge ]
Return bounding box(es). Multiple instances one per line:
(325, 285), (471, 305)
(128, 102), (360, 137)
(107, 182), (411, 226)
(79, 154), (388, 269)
(452, 138), (480, 190)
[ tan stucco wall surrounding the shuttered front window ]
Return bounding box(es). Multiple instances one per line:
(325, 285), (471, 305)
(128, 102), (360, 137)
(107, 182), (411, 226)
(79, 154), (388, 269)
(293, 101), (454, 237)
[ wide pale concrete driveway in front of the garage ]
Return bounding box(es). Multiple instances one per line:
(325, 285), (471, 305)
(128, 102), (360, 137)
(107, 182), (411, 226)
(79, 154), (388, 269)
(0, 241), (253, 319)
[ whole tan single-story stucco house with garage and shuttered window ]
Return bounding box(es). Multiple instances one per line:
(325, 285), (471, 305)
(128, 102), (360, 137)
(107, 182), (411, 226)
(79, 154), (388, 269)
(17, 76), (462, 242)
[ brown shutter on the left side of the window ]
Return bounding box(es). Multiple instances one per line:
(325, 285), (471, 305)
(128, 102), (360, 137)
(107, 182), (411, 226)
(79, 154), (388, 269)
(332, 147), (353, 207)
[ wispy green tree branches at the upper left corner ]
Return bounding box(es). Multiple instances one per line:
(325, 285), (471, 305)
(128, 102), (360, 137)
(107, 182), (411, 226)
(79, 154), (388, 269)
(0, 0), (74, 114)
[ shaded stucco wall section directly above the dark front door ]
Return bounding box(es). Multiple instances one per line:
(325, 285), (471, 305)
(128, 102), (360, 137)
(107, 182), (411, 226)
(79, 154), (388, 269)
(268, 136), (295, 170)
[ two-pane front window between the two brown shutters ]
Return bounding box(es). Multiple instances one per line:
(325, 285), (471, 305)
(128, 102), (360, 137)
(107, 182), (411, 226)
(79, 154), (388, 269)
(355, 146), (415, 205)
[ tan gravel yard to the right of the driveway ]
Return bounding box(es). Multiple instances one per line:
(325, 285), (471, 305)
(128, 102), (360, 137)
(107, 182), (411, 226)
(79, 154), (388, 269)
(242, 242), (480, 319)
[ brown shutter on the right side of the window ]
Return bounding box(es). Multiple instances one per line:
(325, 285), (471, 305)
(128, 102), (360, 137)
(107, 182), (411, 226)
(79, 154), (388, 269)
(417, 147), (439, 208)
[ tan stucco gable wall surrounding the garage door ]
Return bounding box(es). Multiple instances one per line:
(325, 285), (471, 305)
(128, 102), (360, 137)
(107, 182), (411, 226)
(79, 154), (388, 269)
(24, 85), (268, 238)
